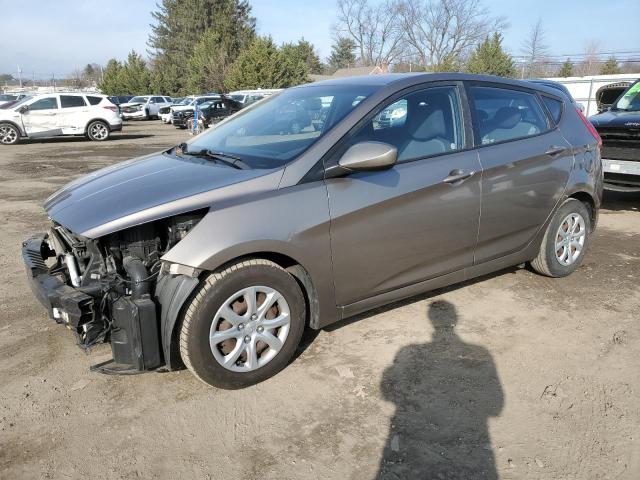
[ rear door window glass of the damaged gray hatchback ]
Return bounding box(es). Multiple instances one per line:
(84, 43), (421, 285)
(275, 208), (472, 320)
(471, 86), (549, 145)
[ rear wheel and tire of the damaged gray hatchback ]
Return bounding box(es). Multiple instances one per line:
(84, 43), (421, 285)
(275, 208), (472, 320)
(531, 198), (591, 277)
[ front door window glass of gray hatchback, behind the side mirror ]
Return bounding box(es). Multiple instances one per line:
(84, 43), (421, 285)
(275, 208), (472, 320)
(345, 86), (464, 163)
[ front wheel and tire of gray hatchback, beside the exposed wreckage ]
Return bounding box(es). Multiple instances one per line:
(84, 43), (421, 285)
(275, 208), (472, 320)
(180, 259), (306, 389)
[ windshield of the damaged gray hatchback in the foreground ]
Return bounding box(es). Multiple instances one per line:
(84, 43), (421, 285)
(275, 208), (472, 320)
(189, 85), (377, 168)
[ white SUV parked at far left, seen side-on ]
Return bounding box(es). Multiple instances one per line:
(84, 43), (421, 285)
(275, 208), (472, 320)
(0, 93), (122, 145)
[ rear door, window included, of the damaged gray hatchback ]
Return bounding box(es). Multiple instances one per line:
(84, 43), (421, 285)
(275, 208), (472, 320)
(468, 82), (574, 263)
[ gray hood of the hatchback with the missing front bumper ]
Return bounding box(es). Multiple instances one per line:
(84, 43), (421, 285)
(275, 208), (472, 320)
(44, 153), (282, 238)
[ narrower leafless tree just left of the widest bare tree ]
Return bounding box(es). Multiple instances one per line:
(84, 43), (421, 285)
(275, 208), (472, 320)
(334, 0), (403, 66)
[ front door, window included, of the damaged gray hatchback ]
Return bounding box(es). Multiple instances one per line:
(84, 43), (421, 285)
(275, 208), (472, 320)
(326, 86), (481, 306)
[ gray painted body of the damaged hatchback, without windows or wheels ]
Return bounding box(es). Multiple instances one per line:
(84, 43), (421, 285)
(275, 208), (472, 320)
(46, 74), (602, 360)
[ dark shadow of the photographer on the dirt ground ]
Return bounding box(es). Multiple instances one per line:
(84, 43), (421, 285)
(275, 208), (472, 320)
(378, 301), (503, 480)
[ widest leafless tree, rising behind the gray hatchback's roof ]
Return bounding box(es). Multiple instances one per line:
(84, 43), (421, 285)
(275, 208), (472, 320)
(396, 0), (506, 68)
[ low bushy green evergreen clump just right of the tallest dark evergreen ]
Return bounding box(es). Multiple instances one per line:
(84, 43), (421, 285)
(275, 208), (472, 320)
(225, 37), (309, 90)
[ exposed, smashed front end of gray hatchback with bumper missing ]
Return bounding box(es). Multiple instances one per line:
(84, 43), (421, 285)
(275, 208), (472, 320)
(22, 210), (206, 374)
